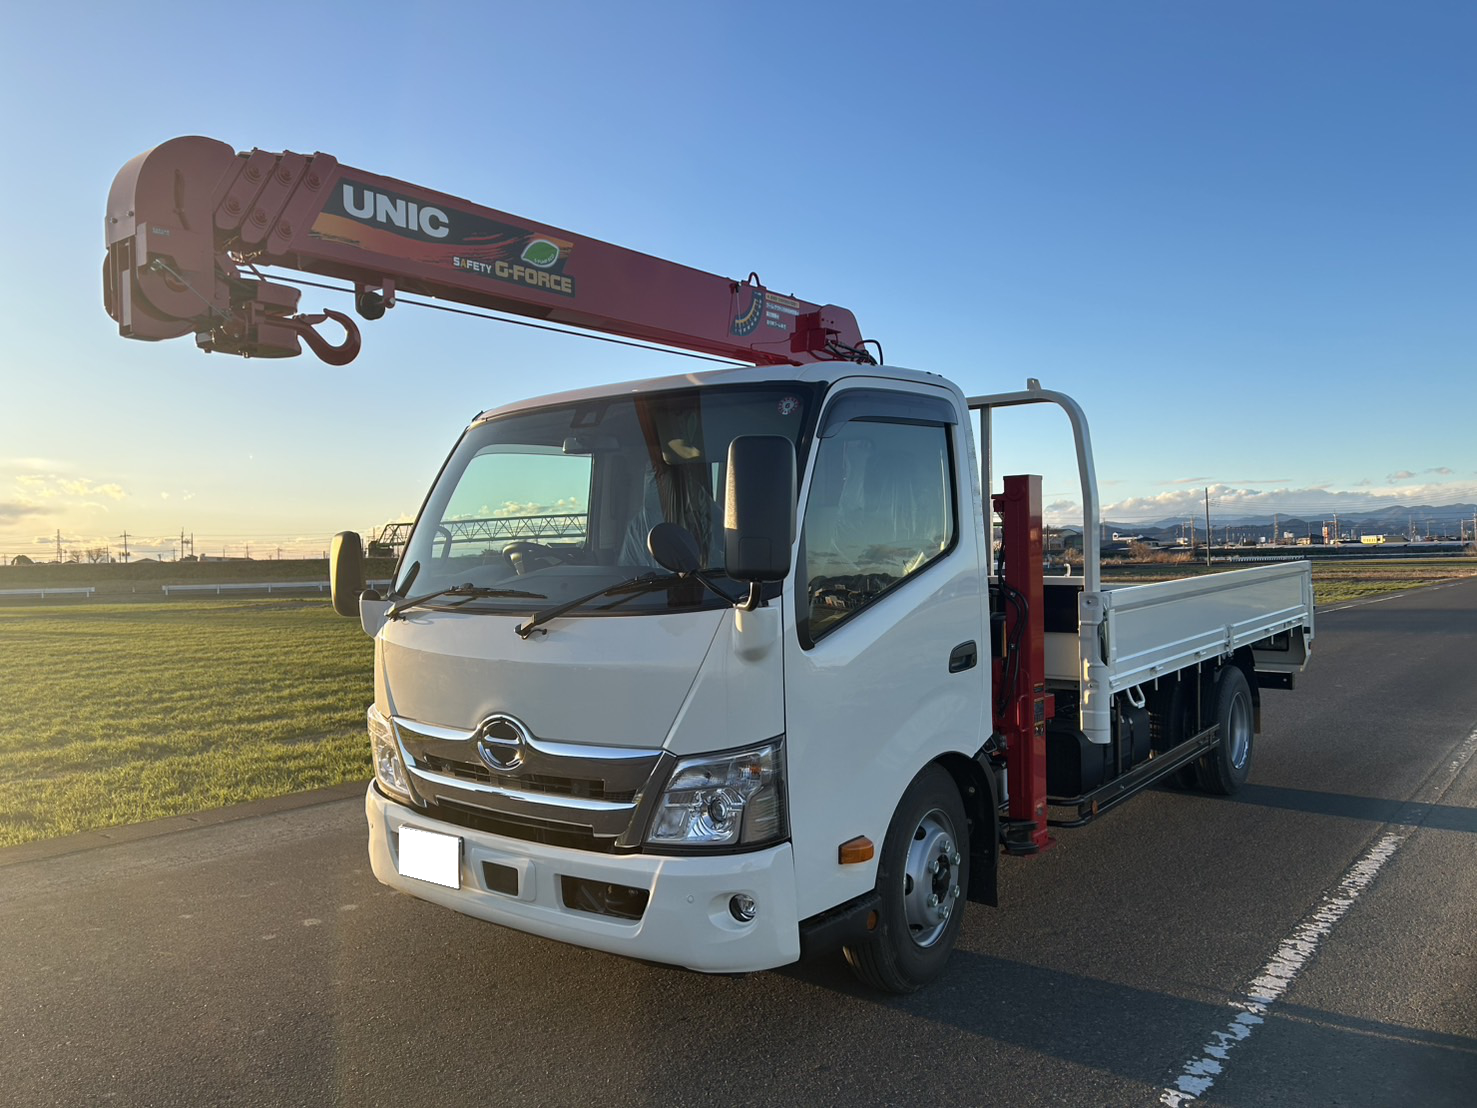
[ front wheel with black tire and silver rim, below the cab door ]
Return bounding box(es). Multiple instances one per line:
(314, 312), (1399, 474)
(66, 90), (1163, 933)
(845, 765), (969, 993)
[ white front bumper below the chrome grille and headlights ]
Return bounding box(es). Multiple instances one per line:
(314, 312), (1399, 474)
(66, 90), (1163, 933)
(365, 783), (801, 974)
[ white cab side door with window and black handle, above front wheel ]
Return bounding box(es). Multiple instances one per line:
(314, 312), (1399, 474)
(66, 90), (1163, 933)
(784, 381), (988, 919)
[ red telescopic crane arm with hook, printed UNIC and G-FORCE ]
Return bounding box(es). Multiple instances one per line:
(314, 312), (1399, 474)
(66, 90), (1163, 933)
(103, 137), (871, 365)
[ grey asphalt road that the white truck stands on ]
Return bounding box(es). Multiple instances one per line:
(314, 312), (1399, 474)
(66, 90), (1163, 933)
(0, 582), (1477, 1108)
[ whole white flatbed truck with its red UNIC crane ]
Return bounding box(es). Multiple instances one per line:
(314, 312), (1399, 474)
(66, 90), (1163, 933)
(105, 139), (1313, 991)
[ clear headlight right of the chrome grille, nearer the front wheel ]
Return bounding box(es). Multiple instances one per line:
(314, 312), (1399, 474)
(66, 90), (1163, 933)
(647, 742), (789, 847)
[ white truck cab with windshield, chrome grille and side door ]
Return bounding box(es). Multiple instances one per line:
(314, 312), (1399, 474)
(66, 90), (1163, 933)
(351, 366), (995, 998)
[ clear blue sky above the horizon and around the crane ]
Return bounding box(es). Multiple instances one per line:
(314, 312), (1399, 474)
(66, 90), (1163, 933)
(0, 0), (1477, 557)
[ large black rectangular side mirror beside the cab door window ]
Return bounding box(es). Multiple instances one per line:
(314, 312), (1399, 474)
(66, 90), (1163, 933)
(724, 434), (795, 593)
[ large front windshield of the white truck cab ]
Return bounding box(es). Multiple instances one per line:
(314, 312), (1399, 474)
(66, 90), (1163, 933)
(396, 383), (815, 615)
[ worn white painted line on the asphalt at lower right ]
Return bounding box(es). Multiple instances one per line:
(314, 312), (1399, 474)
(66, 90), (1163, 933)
(1159, 731), (1477, 1108)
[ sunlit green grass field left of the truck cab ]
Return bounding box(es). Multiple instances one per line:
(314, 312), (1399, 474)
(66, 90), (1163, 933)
(0, 600), (374, 845)
